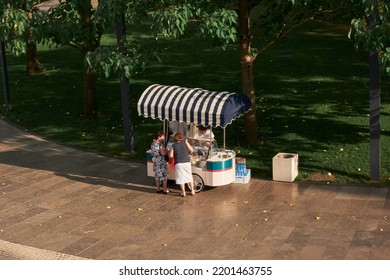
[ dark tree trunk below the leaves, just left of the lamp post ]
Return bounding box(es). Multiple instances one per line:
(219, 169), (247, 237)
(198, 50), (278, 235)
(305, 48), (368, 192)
(83, 63), (97, 119)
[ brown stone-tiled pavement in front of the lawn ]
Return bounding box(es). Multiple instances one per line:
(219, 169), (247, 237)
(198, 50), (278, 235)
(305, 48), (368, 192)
(0, 116), (390, 260)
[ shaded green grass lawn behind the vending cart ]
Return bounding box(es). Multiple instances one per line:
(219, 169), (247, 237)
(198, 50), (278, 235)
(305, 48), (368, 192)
(0, 22), (390, 184)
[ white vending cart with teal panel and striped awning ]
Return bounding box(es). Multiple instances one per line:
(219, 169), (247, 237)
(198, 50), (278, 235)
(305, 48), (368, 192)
(137, 84), (250, 192)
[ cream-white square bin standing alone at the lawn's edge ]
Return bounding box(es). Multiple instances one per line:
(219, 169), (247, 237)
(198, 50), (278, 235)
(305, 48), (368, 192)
(272, 153), (298, 182)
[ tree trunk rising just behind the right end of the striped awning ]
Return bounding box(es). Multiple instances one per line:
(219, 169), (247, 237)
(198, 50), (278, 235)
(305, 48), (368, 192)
(239, 0), (258, 146)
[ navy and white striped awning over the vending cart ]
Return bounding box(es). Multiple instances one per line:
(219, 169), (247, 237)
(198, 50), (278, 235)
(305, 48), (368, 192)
(137, 84), (251, 128)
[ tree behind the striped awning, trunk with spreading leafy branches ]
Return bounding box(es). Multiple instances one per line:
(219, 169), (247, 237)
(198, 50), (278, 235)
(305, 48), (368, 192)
(151, 0), (354, 146)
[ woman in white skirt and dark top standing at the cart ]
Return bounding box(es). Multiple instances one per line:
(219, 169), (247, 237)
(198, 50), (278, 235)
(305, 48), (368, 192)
(169, 132), (195, 197)
